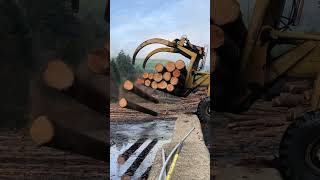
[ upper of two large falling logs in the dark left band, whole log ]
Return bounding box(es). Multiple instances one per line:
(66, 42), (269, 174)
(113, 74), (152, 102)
(43, 60), (109, 115)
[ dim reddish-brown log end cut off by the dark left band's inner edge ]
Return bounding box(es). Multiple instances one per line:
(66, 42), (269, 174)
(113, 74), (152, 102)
(88, 49), (109, 75)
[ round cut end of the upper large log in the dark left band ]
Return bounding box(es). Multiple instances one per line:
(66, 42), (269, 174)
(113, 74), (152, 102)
(43, 60), (74, 90)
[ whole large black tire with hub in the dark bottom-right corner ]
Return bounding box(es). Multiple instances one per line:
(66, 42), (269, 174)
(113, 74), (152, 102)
(279, 110), (320, 180)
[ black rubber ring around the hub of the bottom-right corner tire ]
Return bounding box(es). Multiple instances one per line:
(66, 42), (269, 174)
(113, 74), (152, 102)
(280, 113), (320, 180)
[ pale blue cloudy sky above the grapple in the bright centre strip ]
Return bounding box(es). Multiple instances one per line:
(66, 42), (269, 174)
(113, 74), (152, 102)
(110, 0), (210, 62)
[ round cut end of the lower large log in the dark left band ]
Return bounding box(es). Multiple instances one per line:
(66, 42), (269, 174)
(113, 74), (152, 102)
(30, 116), (54, 145)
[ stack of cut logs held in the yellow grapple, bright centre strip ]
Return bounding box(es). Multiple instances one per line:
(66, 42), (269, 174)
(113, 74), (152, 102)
(137, 60), (187, 95)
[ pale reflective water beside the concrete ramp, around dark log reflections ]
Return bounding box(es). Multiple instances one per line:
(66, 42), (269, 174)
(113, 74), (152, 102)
(110, 121), (174, 180)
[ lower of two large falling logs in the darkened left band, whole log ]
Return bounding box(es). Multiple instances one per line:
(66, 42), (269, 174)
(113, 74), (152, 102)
(29, 116), (109, 162)
